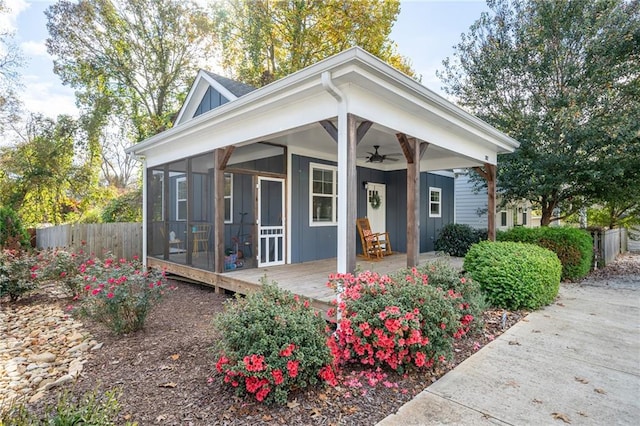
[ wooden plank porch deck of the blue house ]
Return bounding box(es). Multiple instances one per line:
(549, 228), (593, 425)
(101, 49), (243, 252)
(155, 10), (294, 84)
(147, 252), (462, 312)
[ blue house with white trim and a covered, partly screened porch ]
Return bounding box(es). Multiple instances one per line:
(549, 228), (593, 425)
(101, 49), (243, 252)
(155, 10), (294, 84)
(127, 47), (518, 284)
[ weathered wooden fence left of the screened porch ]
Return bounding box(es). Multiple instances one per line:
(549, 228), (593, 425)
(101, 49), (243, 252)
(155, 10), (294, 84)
(36, 222), (142, 259)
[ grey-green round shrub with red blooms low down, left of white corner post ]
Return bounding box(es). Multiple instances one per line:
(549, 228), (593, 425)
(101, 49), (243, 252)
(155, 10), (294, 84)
(214, 279), (331, 404)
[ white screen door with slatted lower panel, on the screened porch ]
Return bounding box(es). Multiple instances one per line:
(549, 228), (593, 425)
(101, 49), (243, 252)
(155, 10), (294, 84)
(258, 177), (285, 267)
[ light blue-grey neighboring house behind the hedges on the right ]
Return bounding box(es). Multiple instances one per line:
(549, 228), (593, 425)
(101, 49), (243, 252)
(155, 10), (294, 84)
(455, 170), (540, 230)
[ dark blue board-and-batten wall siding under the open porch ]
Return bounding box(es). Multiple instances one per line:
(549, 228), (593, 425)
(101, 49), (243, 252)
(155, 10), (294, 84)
(290, 155), (454, 263)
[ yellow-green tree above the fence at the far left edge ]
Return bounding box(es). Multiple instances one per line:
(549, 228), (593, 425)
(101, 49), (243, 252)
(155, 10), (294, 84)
(0, 115), (92, 224)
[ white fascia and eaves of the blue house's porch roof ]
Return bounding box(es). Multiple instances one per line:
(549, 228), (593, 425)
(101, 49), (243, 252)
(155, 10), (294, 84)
(126, 47), (519, 170)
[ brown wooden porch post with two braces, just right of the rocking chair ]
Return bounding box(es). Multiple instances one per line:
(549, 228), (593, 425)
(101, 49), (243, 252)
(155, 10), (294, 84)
(396, 133), (428, 268)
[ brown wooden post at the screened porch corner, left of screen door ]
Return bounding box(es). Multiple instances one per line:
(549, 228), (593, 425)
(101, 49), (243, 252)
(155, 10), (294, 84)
(213, 146), (234, 273)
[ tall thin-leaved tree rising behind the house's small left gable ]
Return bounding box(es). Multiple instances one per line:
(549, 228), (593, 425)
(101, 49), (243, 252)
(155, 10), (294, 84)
(45, 0), (212, 187)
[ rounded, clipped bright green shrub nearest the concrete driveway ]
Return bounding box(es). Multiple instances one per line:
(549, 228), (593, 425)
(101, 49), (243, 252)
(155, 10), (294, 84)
(464, 241), (562, 309)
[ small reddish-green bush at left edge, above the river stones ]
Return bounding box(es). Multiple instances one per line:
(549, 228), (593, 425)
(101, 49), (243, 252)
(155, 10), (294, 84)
(0, 250), (38, 302)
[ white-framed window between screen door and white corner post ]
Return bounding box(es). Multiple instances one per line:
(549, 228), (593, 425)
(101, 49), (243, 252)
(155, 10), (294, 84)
(309, 163), (338, 226)
